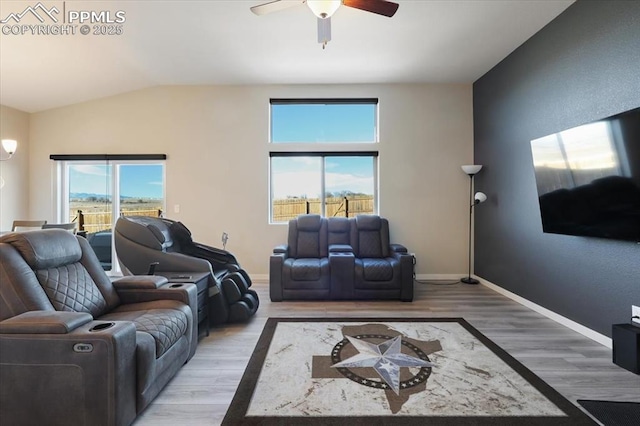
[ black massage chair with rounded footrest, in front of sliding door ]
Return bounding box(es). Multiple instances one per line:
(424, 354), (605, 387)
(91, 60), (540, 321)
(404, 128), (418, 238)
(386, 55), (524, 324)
(114, 216), (259, 325)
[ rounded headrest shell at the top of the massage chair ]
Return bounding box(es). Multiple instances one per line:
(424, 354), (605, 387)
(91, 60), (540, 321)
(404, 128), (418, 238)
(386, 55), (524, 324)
(116, 216), (173, 250)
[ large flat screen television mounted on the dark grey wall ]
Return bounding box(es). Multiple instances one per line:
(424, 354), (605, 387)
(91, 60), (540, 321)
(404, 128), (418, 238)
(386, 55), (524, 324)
(531, 108), (640, 242)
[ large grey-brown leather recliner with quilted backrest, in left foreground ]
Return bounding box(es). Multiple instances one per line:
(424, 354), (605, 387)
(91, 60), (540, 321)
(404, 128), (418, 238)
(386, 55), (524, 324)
(0, 229), (197, 425)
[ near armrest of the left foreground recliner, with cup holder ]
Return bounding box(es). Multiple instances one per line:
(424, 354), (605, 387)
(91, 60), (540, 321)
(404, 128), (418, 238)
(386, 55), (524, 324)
(0, 320), (136, 425)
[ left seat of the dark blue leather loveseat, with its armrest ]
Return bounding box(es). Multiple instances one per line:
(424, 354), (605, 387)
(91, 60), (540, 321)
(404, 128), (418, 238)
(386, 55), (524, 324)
(269, 214), (331, 302)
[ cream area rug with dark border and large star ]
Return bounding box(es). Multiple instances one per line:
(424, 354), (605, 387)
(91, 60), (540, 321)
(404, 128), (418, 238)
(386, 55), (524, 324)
(222, 318), (596, 426)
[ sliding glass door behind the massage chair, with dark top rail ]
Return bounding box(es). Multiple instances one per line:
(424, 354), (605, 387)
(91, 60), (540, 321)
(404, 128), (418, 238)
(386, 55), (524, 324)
(51, 155), (165, 271)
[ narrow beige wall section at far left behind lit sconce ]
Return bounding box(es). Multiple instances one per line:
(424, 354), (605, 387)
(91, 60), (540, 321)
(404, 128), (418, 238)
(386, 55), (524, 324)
(0, 105), (29, 231)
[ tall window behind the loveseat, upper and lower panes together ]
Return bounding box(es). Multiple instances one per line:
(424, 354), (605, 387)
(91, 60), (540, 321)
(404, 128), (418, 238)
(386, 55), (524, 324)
(270, 99), (378, 223)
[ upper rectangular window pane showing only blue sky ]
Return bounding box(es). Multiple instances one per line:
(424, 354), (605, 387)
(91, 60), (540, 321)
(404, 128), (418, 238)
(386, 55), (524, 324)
(271, 99), (378, 143)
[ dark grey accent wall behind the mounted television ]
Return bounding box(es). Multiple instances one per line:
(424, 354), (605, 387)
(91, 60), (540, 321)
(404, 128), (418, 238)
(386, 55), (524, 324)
(473, 0), (640, 336)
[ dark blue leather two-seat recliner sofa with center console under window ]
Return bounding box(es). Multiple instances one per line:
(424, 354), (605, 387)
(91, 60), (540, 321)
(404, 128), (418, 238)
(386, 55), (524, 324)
(269, 215), (413, 302)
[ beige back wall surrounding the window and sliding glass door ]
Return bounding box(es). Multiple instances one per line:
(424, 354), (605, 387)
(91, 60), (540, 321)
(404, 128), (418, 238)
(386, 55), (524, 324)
(29, 84), (473, 275)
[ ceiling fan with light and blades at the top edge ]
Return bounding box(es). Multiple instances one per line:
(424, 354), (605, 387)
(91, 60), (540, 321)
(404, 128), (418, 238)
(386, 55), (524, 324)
(251, 0), (398, 49)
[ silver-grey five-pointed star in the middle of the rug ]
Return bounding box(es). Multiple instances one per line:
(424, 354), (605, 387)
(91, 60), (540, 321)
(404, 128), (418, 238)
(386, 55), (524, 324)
(332, 336), (433, 395)
